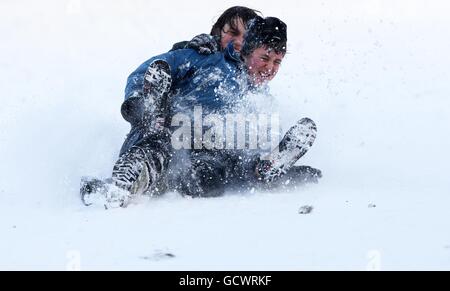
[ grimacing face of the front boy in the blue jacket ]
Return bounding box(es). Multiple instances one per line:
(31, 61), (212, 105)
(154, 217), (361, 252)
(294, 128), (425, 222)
(244, 47), (284, 85)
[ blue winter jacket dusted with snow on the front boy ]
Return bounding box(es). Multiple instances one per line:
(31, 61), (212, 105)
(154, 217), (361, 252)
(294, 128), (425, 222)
(122, 44), (249, 122)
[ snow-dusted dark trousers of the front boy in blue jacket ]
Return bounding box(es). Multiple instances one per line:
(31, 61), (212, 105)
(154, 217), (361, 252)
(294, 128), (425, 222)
(120, 124), (258, 197)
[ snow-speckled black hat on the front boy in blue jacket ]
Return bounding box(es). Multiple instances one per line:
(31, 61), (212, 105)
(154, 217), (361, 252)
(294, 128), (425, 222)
(241, 16), (287, 56)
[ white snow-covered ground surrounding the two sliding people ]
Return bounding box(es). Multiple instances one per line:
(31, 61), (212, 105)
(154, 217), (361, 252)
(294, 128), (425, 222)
(0, 0), (450, 270)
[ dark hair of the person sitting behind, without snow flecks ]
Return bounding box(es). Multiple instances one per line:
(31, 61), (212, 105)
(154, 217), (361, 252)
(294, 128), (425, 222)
(210, 6), (261, 37)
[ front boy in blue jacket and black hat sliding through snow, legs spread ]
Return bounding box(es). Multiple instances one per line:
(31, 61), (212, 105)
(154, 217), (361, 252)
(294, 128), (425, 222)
(81, 17), (320, 206)
